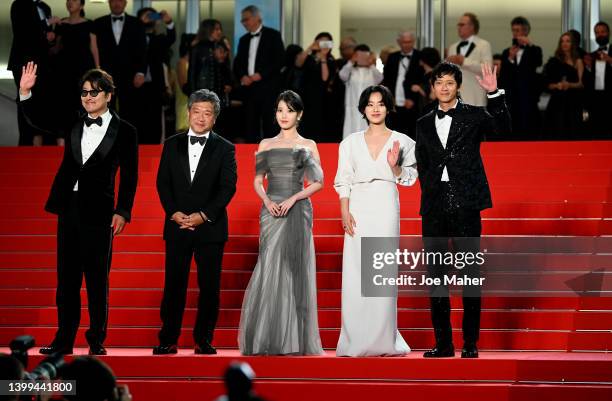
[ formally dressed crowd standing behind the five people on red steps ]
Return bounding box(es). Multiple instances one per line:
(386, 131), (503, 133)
(8, 0), (612, 145)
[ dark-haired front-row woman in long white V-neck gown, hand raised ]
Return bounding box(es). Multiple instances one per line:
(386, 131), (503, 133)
(334, 85), (417, 356)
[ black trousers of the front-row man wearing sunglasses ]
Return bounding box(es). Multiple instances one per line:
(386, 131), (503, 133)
(53, 192), (113, 347)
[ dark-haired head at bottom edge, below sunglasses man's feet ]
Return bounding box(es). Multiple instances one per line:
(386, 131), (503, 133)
(62, 356), (117, 401)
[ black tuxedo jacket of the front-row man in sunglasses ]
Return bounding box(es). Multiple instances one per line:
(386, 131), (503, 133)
(20, 99), (138, 225)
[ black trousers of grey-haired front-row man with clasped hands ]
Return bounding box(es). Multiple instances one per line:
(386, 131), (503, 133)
(159, 231), (225, 345)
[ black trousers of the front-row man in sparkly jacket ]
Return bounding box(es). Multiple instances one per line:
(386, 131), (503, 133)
(422, 183), (482, 347)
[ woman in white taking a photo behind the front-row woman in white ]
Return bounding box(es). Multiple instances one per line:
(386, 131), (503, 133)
(338, 45), (383, 138)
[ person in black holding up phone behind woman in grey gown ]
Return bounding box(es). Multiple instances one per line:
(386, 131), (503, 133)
(295, 32), (338, 142)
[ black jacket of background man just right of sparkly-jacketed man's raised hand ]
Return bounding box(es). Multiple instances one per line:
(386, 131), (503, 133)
(499, 46), (543, 107)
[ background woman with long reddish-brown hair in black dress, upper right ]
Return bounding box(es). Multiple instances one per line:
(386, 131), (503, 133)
(544, 32), (584, 139)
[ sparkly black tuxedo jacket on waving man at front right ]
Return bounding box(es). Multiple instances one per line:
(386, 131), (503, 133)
(415, 95), (510, 215)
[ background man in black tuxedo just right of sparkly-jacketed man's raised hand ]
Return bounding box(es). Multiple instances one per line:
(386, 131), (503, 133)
(499, 17), (542, 140)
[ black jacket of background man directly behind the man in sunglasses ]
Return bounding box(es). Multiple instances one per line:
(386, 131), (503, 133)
(94, 14), (147, 87)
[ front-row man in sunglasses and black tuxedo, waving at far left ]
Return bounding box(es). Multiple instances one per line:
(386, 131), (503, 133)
(19, 63), (138, 355)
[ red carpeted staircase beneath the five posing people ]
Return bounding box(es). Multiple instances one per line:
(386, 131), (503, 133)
(0, 142), (612, 401)
